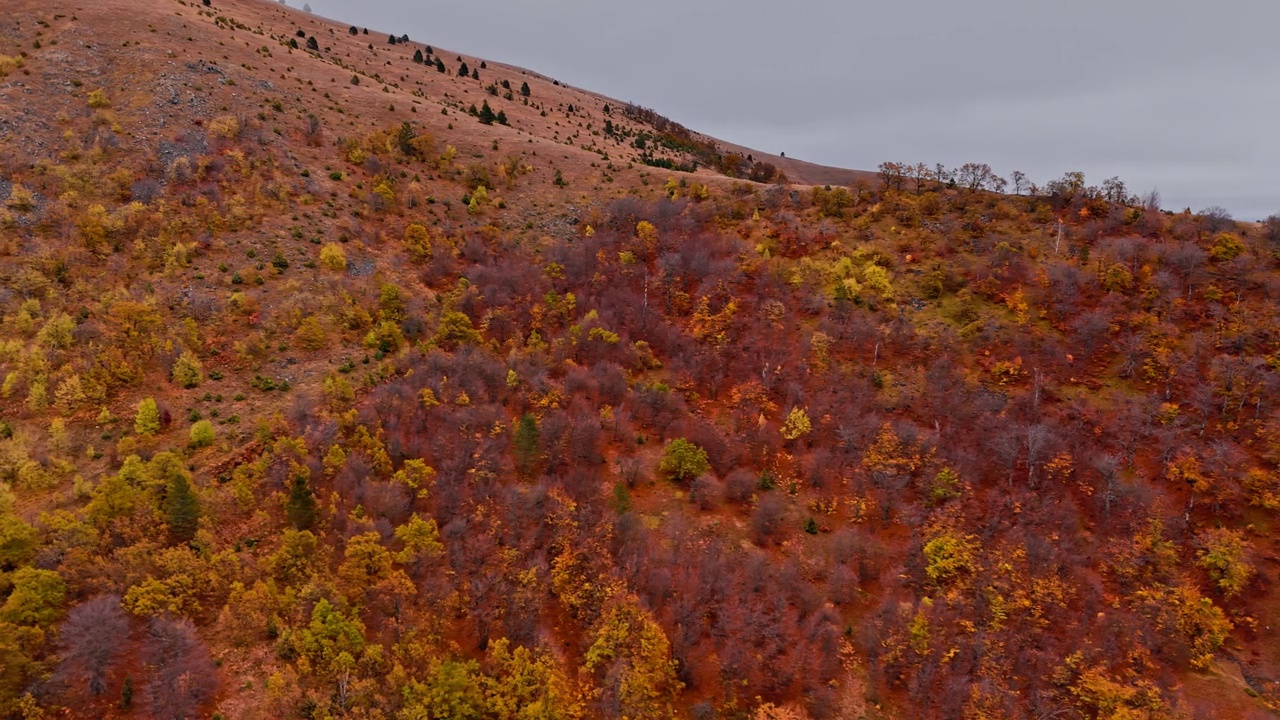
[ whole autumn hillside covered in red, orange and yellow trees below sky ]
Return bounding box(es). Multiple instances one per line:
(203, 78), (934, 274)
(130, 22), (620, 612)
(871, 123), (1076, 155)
(0, 0), (1280, 720)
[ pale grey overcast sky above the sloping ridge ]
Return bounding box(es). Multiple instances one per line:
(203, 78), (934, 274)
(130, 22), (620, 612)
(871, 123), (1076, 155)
(302, 0), (1280, 219)
